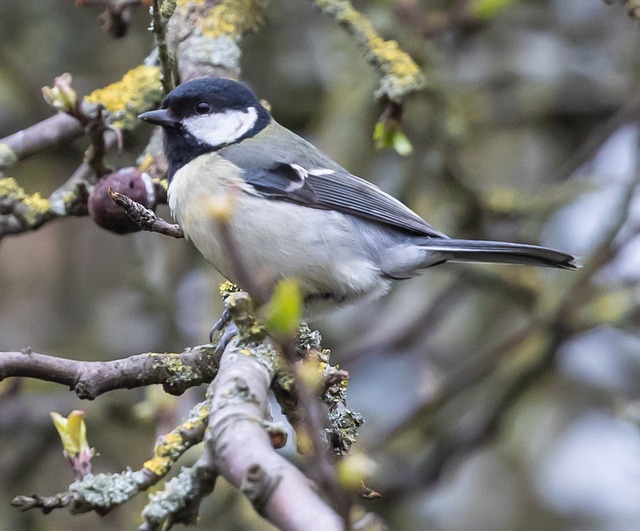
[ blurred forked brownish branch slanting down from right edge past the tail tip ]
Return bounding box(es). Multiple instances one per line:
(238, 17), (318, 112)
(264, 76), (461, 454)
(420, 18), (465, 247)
(381, 111), (640, 484)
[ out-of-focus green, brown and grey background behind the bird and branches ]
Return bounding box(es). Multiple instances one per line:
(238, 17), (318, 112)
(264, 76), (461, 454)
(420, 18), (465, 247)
(0, 0), (640, 531)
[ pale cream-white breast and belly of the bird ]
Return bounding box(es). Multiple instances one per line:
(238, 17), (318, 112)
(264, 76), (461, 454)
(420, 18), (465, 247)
(169, 156), (388, 310)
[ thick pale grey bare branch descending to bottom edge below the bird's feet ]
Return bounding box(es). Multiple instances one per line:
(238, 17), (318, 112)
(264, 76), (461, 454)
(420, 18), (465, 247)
(206, 344), (344, 531)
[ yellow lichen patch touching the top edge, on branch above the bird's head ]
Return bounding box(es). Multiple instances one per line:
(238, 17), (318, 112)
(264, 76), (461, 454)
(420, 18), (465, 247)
(198, 0), (264, 38)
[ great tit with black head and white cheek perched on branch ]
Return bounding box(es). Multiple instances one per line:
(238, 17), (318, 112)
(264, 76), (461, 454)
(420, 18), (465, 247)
(140, 78), (578, 315)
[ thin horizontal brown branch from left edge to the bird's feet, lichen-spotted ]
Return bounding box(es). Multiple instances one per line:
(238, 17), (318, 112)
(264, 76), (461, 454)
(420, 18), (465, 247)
(0, 345), (217, 400)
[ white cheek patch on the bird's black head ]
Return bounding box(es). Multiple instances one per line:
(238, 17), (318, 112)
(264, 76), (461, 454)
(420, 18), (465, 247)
(183, 107), (258, 146)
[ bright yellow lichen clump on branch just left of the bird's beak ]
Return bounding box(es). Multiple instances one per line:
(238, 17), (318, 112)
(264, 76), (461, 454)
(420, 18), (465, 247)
(84, 65), (162, 129)
